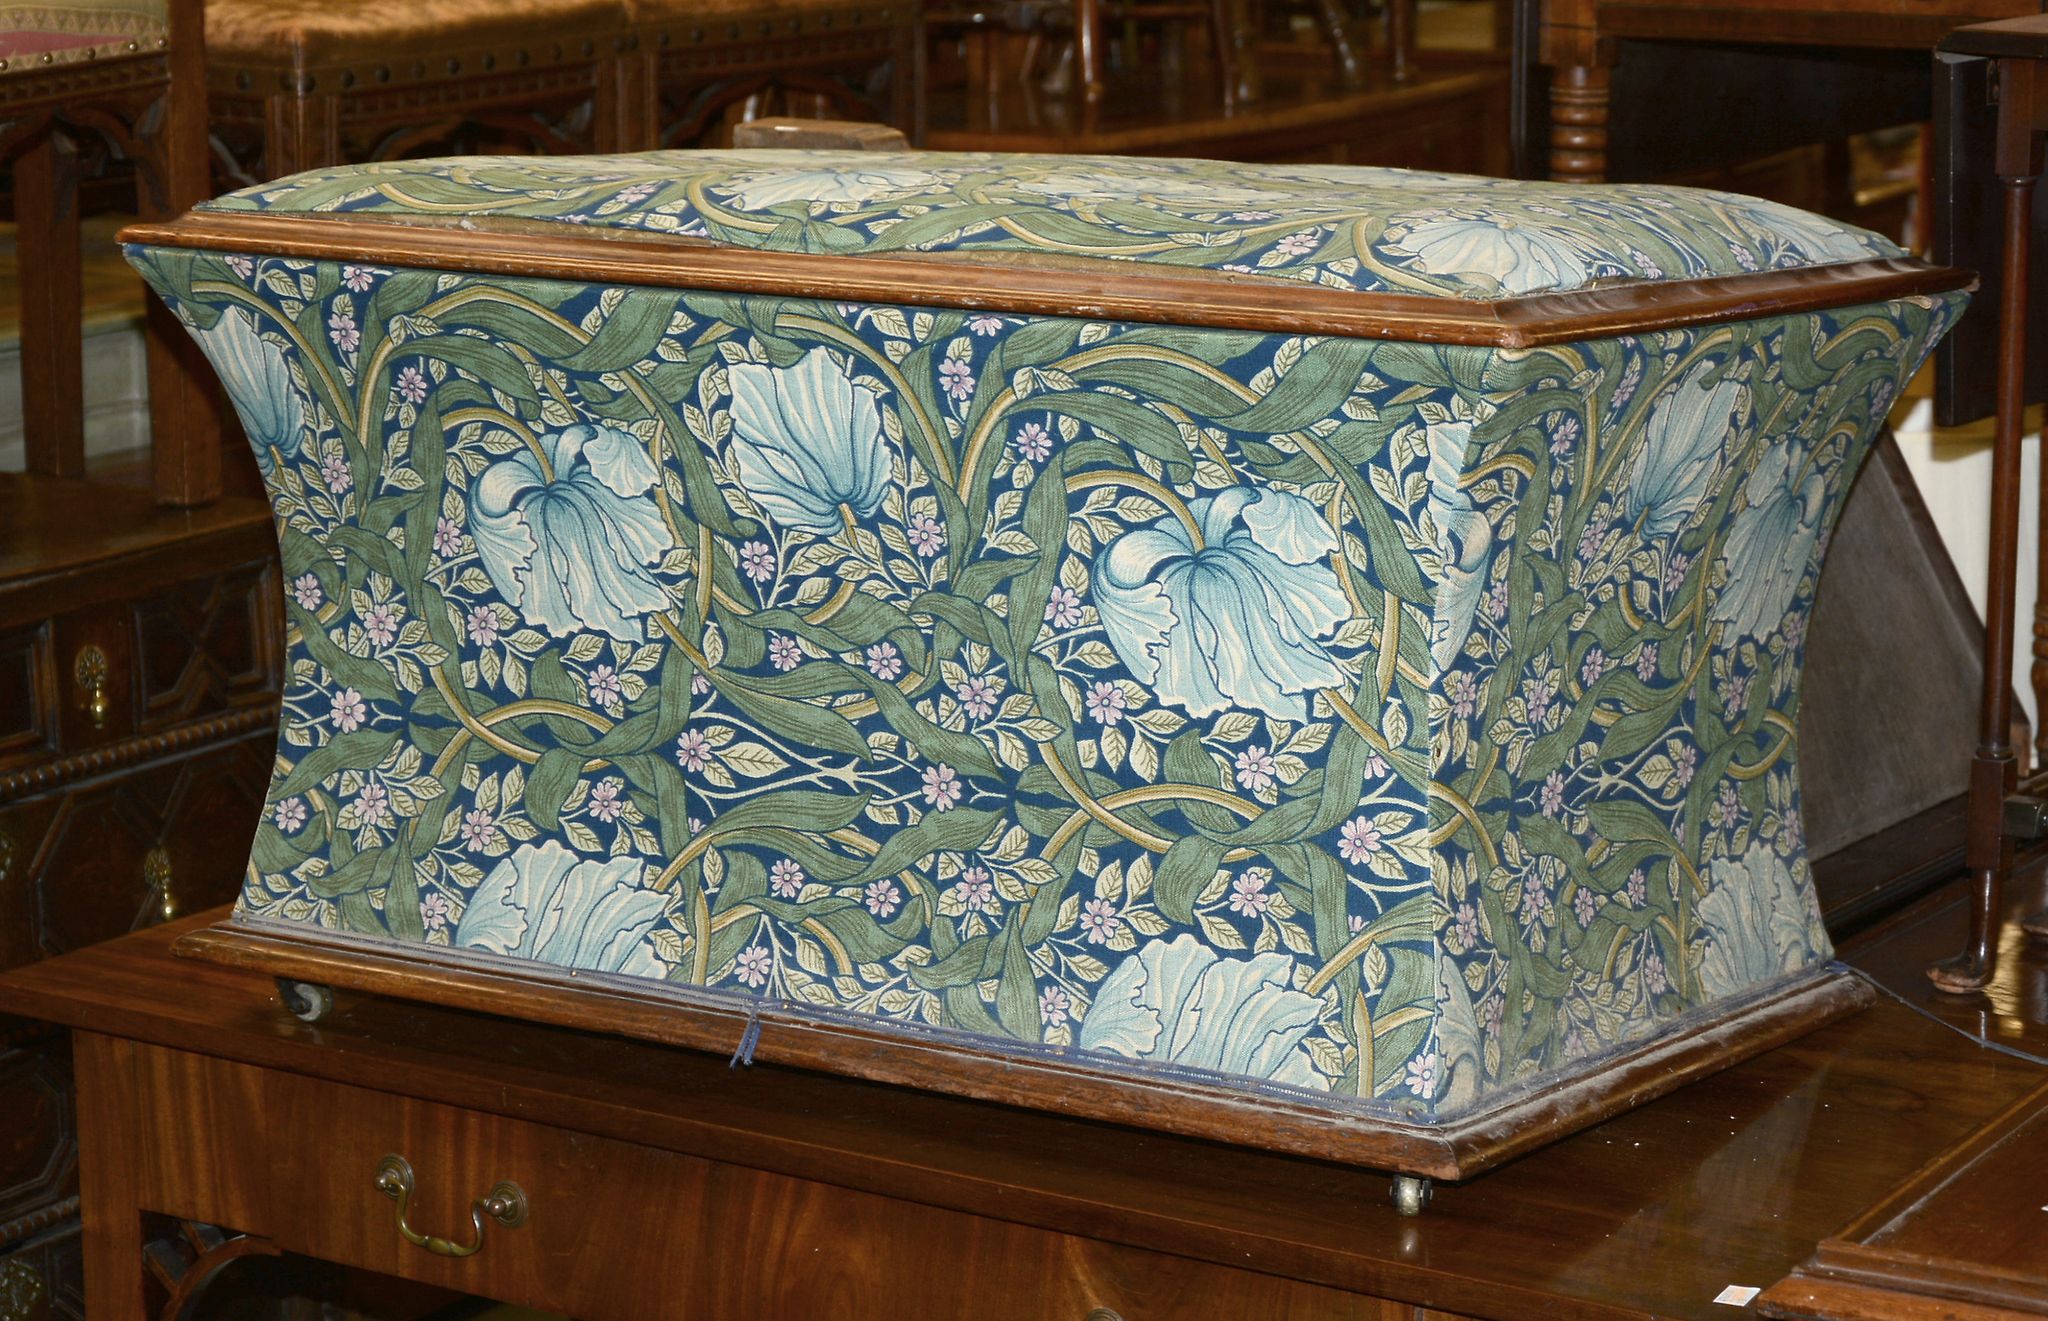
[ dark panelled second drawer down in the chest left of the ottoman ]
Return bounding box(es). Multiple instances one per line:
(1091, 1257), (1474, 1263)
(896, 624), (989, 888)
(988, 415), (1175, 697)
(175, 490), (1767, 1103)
(0, 729), (276, 969)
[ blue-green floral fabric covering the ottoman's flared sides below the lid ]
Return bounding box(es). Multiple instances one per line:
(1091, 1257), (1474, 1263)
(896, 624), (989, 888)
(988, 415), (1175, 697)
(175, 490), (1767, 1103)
(131, 156), (1962, 1118)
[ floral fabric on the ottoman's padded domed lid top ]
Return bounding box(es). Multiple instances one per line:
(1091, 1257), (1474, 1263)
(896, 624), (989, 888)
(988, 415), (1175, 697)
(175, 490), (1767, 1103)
(195, 150), (1901, 299)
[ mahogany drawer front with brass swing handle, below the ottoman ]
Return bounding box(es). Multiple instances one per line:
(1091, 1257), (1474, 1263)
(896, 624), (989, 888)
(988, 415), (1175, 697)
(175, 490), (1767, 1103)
(103, 1036), (1413, 1321)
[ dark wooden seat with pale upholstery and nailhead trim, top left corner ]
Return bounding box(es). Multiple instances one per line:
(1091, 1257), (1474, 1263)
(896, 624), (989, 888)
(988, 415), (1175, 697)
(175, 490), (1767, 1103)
(0, 0), (221, 504)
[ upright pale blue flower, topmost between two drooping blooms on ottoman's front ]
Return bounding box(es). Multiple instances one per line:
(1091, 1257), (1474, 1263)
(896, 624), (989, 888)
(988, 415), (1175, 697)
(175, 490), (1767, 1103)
(727, 348), (889, 535)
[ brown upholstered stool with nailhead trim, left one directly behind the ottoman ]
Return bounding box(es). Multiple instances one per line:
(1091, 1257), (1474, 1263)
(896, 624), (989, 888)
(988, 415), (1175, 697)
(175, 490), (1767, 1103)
(207, 0), (651, 182)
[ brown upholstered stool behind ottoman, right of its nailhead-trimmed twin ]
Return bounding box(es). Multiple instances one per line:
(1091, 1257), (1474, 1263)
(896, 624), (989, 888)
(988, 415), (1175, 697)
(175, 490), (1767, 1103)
(625, 0), (924, 147)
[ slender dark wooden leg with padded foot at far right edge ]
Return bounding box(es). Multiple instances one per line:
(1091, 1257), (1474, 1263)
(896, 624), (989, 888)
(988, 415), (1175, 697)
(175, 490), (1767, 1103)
(1927, 59), (2042, 993)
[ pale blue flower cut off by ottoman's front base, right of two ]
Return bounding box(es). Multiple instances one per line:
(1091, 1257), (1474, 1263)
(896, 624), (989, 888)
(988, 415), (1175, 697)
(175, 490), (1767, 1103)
(1075, 934), (1329, 1092)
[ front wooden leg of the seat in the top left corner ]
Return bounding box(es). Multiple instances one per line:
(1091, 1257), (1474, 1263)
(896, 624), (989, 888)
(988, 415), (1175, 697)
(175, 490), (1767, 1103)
(14, 125), (86, 477)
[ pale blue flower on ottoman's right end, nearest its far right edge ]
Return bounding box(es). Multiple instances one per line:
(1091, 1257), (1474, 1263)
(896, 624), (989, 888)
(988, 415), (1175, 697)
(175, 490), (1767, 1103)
(1712, 440), (1827, 643)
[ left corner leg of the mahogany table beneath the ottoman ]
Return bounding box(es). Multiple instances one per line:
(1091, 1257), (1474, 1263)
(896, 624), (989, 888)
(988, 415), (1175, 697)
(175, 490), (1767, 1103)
(74, 1032), (150, 1321)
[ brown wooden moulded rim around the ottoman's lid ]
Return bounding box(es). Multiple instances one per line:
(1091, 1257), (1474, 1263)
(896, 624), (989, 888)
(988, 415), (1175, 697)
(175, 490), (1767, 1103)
(121, 211), (1976, 350)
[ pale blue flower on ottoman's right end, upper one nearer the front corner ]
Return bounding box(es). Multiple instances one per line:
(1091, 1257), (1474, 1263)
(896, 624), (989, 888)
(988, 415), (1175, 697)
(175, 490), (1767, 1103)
(1624, 363), (1749, 541)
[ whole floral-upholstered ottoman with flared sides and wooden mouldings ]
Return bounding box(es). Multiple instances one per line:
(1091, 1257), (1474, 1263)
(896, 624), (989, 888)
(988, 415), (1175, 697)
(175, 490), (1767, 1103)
(131, 152), (1964, 1176)
